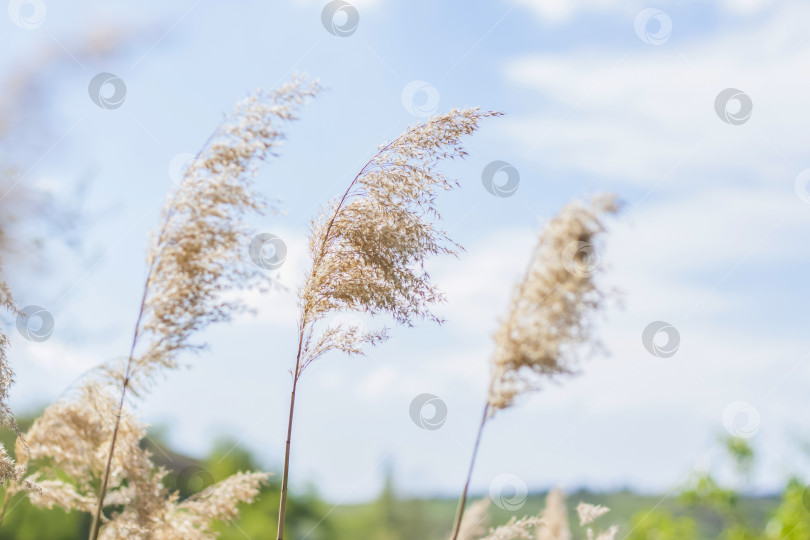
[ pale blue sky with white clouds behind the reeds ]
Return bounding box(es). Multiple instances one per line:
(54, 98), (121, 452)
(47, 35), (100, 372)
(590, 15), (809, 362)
(0, 0), (810, 501)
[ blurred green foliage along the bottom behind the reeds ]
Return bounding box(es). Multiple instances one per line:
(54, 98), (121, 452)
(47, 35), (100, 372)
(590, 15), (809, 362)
(0, 422), (810, 540)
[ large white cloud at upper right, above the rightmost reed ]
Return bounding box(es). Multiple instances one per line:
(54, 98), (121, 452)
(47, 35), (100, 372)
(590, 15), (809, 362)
(503, 2), (810, 191)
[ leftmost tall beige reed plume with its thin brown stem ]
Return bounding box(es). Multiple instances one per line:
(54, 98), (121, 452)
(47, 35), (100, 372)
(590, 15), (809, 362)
(90, 78), (319, 540)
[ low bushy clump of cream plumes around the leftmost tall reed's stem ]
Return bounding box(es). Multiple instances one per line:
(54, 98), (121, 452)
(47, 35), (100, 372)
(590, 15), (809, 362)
(21, 381), (267, 540)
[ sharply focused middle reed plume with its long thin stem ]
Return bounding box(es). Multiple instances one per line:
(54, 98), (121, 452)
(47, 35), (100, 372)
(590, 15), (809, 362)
(278, 109), (500, 540)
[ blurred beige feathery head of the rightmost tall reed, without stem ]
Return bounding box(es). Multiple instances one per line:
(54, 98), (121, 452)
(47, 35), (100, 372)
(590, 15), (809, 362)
(489, 195), (618, 412)
